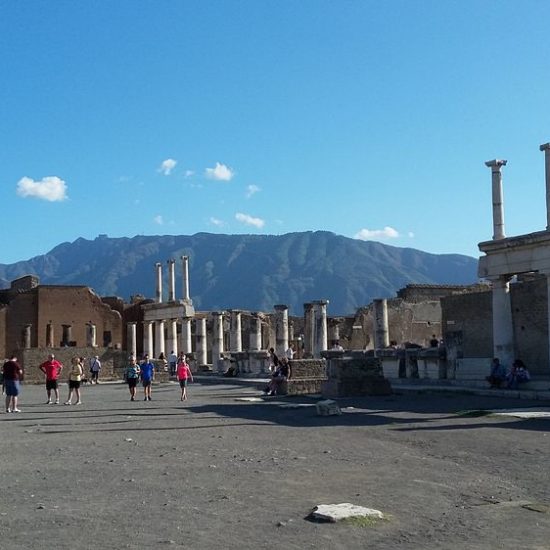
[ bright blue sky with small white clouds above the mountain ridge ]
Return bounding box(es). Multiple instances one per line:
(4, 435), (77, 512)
(0, 0), (550, 263)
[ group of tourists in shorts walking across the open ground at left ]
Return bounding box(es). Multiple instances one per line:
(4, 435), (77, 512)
(2, 352), (193, 413)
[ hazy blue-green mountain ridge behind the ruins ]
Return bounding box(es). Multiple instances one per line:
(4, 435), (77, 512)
(0, 231), (478, 315)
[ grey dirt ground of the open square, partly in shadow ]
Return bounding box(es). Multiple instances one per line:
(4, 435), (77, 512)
(0, 380), (550, 550)
